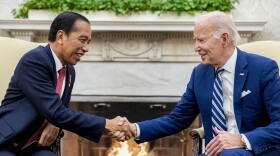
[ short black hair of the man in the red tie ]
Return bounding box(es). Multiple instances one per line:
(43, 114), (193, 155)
(48, 11), (90, 42)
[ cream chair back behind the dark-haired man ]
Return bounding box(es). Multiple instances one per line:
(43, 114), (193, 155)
(0, 37), (46, 101)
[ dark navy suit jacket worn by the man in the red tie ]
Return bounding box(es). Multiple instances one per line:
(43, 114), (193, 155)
(0, 45), (106, 146)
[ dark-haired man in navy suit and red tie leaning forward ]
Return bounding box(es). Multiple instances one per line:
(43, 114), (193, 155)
(0, 12), (131, 156)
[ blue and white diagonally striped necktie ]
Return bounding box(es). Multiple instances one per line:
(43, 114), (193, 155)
(212, 68), (227, 137)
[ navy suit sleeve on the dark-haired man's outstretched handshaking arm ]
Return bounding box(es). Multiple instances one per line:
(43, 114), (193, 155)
(15, 53), (106, 142)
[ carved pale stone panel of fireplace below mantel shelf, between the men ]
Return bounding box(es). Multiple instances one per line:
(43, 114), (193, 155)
(83, 32), (199, 62)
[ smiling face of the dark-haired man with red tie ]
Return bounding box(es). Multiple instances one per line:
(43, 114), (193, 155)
(57, 20), (91, 65)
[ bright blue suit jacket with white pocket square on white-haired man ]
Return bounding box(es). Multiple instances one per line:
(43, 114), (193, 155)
(137, 49), (280, 154)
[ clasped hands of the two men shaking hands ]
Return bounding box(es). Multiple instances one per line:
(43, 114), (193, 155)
(105, 116), (137, 141)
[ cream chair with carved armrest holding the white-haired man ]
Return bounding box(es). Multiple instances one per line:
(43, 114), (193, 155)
(189, 41), (280, 155)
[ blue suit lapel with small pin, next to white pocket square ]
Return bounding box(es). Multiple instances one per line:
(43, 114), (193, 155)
(233, 49), (248, 130)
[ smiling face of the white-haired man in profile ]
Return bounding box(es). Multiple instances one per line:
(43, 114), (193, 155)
(194, 21), (225, 67)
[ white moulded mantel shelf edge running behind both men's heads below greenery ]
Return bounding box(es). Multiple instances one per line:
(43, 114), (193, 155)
(0, 19), (266, 33)
